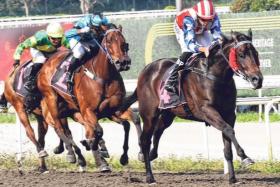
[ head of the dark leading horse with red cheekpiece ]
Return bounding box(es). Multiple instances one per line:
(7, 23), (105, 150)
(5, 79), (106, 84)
(223, 29), (263, 89)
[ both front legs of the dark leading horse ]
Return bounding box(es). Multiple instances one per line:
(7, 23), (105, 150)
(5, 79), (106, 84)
(200, 106), (252, 183)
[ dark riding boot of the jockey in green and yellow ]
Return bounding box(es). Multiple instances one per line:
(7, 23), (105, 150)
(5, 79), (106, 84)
(24, 63), (43, 93)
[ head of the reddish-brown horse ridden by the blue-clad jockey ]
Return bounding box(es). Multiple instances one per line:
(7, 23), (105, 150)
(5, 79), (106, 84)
(102, 27), (131, 71)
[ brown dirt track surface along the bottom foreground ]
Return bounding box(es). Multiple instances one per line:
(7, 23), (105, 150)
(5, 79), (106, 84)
(0, 170), (280, 187)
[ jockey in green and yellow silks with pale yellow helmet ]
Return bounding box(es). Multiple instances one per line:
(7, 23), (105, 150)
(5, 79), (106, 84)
(13, 23), (69, 92)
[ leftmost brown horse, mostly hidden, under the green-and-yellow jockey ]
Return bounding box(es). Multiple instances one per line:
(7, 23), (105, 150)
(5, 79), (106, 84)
(1, 67), (86, 172)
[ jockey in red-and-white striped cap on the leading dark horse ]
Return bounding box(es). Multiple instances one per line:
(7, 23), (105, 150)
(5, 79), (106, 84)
(165, 0), (222, 93)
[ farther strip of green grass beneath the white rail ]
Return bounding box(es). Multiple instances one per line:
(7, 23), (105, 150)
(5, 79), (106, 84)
(0, 112), (280, 124)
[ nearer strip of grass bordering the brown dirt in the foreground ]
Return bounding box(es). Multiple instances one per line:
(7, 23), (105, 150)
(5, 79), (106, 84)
(0, 155), (280, 173)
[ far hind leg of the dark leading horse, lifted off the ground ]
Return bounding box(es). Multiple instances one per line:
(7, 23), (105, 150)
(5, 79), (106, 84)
(150, 111), (175, 161)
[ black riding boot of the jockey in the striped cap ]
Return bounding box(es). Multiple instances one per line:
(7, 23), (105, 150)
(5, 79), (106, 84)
(164, 52), (192, 93)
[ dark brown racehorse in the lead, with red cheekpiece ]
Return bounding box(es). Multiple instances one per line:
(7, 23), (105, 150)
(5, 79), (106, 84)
(119, 30), (263, 183)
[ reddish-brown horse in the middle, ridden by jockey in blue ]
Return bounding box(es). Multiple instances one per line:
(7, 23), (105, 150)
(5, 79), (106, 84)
(37, 25), (141, 167)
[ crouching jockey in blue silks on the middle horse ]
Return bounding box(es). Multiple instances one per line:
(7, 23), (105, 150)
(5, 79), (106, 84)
(65, 14), (110, 84)
